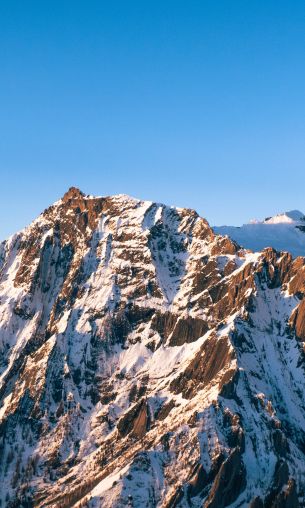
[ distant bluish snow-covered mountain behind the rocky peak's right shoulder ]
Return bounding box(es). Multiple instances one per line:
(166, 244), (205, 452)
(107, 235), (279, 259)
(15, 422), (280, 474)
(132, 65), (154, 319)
(213, 210), (305, 257)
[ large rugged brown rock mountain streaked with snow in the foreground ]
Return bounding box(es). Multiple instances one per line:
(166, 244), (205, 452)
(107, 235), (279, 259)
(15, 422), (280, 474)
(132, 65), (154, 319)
(0, 188), (305, 508)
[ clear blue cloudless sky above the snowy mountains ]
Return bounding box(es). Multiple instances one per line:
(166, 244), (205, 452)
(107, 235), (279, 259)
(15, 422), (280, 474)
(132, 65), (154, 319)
(0, 0), (305, 238)
